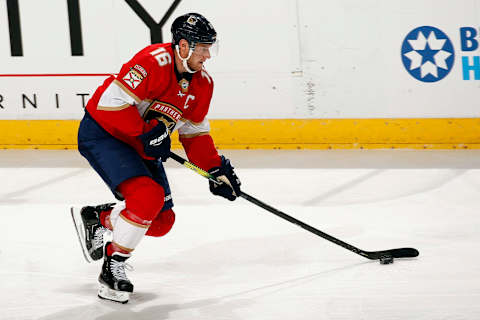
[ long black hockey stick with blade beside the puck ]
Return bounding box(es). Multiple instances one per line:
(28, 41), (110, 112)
(170, 152), (419, 261)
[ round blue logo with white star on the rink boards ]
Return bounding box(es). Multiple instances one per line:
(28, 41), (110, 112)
(402, 26), (455, 82)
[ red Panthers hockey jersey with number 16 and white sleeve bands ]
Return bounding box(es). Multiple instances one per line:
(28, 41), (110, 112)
(86, 43), (220, 170)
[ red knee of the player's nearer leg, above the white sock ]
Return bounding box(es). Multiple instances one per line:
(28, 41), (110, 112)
(118, 176), (165, 221)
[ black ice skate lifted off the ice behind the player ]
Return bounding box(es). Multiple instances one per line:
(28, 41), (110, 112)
(70, 203), (114, 262)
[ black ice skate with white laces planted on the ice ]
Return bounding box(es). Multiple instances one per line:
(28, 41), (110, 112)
(98, 242), (133, 303)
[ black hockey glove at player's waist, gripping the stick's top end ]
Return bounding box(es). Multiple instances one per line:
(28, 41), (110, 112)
(138, 121), (171, 161)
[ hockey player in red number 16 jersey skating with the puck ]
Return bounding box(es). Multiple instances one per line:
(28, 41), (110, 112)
(71, 13), (240, 303)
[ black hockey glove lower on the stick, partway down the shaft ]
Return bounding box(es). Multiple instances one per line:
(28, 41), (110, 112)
(208, 156), (241, 201)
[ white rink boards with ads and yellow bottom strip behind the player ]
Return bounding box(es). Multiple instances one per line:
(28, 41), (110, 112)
(0, 0), (480, 149)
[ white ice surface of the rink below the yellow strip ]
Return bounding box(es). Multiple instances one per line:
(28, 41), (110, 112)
(0, 150), (480, 320)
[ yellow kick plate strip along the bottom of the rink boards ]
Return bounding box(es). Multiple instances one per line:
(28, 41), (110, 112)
(0, 118), (480, 149)
